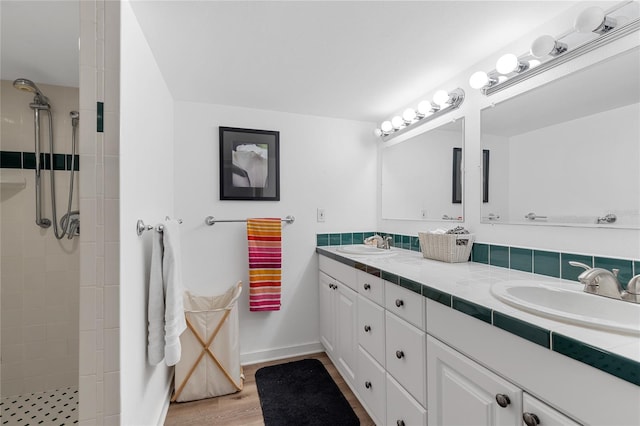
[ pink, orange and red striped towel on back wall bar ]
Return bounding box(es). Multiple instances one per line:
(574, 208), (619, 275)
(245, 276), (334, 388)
(247, 218), (282, 311)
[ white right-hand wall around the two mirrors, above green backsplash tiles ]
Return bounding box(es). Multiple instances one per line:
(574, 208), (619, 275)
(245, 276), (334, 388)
(378, 4), (640, 259)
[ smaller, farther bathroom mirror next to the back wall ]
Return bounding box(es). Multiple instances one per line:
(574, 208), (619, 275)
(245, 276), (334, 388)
(382, 118), (464, 221)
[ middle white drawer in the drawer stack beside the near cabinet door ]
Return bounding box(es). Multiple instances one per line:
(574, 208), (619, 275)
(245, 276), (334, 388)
(385, 312), (427, 407)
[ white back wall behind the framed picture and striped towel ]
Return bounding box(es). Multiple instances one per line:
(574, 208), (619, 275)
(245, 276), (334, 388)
(174, 102), (376, 363)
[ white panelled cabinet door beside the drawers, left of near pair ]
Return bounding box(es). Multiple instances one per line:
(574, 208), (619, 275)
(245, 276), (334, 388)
(427, 336), (522, 426)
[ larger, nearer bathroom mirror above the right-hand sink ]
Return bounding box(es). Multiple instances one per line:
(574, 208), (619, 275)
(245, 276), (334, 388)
(481, 48), (640, 228)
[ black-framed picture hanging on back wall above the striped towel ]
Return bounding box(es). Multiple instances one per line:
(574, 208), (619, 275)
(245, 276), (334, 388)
(220, 127), (280, 201)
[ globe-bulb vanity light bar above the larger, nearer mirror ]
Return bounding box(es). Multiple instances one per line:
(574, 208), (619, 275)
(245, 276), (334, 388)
(469, 2), (640, 96)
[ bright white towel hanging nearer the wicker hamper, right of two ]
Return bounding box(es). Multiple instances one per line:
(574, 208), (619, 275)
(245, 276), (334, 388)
(162, 220), (187, 366)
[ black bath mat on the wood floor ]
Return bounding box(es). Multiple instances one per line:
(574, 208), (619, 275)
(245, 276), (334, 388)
(255, 359), (360, 426)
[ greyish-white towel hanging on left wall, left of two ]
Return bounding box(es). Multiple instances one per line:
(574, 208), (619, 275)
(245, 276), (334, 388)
(147, 225), (164, 365)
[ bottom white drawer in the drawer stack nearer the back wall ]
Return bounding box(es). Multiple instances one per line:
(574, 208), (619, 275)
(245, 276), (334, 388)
(356, 348), (386, 424)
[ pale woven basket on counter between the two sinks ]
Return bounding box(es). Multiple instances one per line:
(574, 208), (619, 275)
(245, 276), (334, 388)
(418, 232), (475, 263)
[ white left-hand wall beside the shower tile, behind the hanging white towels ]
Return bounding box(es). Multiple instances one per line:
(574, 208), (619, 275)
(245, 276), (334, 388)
(120, 2), (174, 425)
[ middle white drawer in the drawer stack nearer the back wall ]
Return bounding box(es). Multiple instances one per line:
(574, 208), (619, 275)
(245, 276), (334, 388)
(358, 296), (385, 365)
